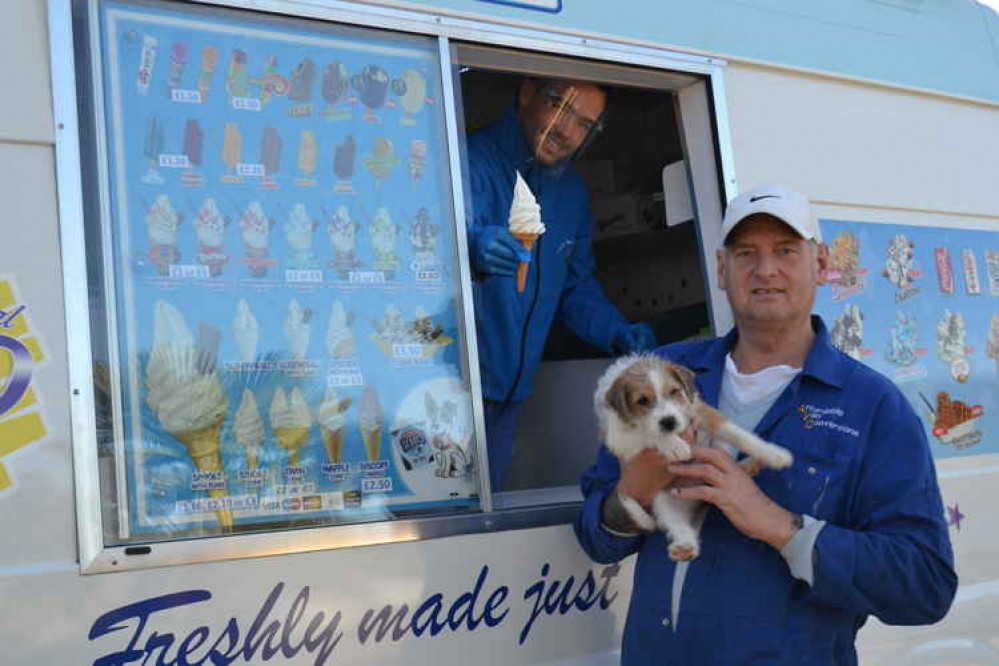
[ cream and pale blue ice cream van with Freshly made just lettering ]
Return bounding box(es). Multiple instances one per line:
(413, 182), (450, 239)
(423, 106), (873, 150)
(0, 0), (999, 666)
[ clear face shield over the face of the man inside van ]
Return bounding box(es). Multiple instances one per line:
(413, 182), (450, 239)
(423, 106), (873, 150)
(527, 83), (606, 171)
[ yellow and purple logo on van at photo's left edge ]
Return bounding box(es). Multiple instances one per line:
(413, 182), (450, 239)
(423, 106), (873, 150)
(0, 278), (48, 493)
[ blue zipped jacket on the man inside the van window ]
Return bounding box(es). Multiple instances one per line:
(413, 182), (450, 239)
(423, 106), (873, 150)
(467, 109), (628, 402)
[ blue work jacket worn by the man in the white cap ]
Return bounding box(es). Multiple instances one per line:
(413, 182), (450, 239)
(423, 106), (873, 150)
(575, 317), (957, 666)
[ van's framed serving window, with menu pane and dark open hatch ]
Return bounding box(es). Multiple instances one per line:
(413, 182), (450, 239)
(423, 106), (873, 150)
(64, 0), (732, 571)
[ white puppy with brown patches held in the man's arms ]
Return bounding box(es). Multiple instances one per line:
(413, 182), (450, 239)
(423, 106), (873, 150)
(594, 354), (792, 561)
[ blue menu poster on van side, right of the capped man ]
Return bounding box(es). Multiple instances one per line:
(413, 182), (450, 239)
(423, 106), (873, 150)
(816, 220), (999, 458)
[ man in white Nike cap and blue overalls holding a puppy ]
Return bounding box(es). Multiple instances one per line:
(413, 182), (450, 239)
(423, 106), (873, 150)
(576, 185), (957, 666)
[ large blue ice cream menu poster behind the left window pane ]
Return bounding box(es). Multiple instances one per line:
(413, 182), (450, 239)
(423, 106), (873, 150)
(97, 3), (478, 534)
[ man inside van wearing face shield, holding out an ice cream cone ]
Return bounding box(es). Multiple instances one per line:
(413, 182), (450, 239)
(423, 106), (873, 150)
(468, 80), (655, 490)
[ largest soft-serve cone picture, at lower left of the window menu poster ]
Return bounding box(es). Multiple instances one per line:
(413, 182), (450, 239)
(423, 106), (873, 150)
(146, 300), (233, 531)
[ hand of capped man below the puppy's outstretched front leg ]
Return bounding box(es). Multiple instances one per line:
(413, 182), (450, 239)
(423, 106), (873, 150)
(668, 447), (799, 550)
